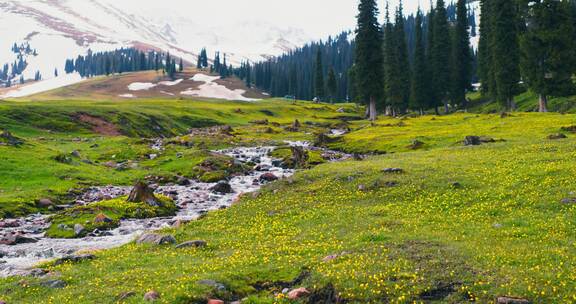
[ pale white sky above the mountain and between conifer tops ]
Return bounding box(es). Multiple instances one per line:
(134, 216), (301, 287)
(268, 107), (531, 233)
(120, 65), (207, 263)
(100, 0), (435, 39)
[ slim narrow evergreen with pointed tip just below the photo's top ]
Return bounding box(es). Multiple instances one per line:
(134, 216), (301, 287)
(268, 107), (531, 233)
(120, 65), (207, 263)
(410, 10), (428, 114)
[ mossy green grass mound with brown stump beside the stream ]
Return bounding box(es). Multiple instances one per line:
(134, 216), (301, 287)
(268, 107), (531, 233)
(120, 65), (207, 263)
(46, 196), (177, 238)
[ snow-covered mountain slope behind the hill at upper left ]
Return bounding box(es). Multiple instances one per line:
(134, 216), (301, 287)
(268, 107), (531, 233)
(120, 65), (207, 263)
(0, 0), (311, 85)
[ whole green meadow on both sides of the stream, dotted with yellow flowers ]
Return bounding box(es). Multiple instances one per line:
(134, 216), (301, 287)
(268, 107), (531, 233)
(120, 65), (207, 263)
(0, 94), (576, 303)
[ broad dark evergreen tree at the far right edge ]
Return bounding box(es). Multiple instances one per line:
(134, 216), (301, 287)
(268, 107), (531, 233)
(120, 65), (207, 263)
(520, 0), (576, 112)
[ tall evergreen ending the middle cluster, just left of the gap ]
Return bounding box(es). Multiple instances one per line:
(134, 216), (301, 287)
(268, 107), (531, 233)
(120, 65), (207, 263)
(450, 0), (472, 107)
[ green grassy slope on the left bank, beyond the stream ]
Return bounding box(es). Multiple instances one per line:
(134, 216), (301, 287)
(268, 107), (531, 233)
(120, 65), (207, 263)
(0, 99), (355, 218)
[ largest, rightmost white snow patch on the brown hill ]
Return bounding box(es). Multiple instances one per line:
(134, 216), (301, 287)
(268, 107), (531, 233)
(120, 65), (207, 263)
(180, 74), (259, 101)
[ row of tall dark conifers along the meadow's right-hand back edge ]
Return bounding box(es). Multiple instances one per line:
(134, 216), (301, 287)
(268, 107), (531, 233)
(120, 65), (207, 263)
(351, 0), (576, 119)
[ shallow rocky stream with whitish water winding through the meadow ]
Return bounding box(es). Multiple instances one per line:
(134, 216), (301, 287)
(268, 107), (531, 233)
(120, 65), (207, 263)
(0, 142), (349, 277)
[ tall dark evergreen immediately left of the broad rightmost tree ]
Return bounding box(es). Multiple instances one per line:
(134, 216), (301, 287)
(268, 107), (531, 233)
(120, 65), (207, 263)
(489, 0), (520, 110)
